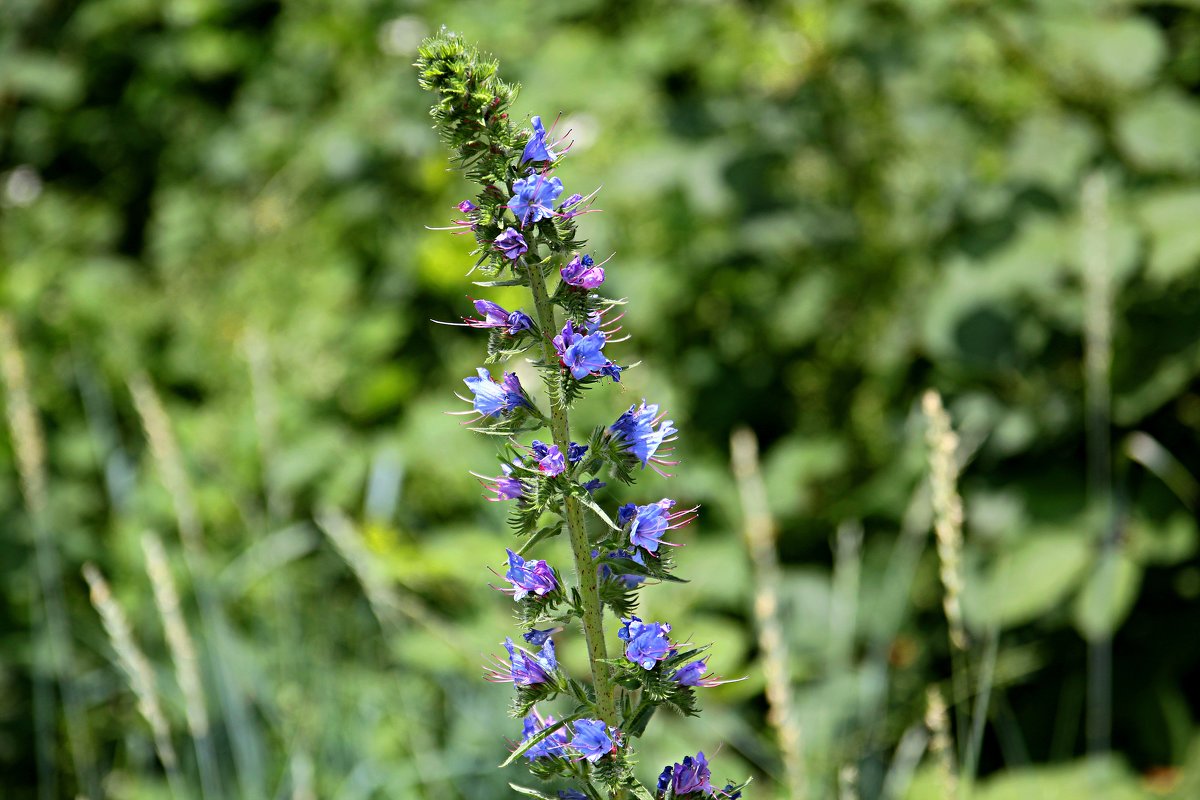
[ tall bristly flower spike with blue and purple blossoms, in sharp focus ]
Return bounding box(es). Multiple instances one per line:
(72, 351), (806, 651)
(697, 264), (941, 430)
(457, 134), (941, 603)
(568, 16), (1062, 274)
(416, 32), (745, 800)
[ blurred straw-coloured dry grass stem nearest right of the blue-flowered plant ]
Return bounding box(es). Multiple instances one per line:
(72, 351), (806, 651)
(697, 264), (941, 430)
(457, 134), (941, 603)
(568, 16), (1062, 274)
(730, 428), (806, 800)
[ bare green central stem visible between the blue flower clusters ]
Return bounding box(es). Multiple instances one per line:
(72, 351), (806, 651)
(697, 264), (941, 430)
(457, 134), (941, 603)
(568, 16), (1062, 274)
(524, 253), (617, 727)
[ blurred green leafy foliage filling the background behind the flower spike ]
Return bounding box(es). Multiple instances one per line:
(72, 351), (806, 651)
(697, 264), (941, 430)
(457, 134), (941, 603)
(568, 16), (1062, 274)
(7, 0), (1200, 799)
